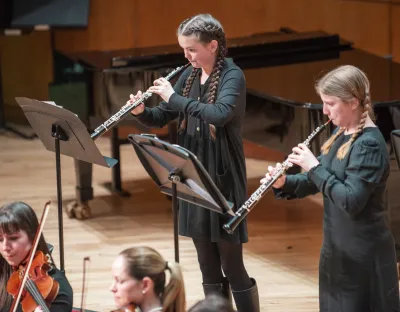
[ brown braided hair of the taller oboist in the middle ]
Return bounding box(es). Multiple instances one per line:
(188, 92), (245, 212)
(177, 14), (227, 140)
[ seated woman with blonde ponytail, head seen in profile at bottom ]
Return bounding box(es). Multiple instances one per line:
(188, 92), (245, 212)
(110, 247), (186, 312)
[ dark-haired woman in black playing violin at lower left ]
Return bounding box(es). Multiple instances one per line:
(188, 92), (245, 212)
(0, 202), (73, 312)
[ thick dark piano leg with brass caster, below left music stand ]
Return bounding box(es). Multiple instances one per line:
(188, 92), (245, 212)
(67, 159), (93, 220)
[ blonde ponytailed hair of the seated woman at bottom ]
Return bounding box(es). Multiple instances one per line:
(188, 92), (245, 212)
(120, 246), (186, 312)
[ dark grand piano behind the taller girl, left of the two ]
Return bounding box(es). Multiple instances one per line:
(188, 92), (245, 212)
(49, 28), (351, 212)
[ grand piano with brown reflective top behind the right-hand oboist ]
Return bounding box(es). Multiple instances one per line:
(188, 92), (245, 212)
(243, 45), (400, 153)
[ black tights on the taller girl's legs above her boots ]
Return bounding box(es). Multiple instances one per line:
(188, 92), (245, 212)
(193, 239), (252, 291)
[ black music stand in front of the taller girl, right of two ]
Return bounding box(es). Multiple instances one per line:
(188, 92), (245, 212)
(128, 134), (234, 262)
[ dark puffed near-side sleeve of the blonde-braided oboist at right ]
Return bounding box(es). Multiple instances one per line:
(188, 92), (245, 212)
(308, 138), (388, 216)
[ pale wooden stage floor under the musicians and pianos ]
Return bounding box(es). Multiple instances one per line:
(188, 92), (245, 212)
(0, 134), (322, 312)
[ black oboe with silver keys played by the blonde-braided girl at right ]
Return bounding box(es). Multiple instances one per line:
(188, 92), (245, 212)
(223, 120), (330, 234)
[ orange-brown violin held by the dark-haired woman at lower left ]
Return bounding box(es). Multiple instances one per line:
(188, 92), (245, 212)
(7, 251), (59, 312)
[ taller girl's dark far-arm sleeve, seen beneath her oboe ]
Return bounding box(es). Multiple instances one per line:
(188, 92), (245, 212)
(136, 67), (188, 128)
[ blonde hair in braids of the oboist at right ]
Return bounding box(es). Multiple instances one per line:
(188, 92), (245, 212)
(315, 65), (375, 159)
